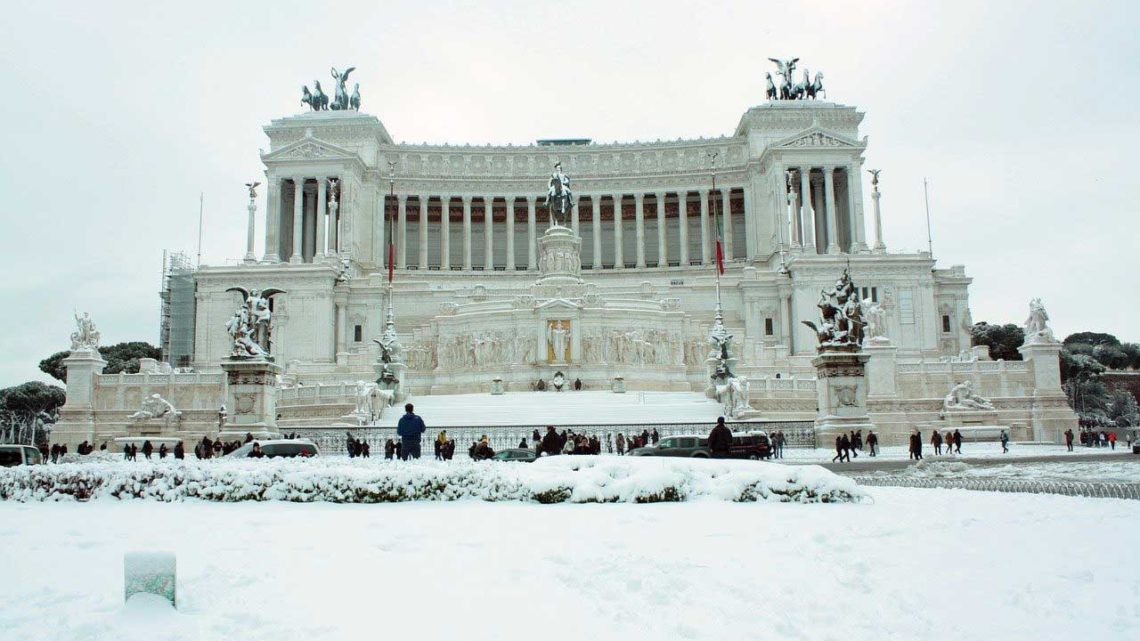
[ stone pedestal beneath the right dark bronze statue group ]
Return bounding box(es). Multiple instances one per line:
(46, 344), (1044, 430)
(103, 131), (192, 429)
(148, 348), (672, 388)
(812, 348), (874, 437)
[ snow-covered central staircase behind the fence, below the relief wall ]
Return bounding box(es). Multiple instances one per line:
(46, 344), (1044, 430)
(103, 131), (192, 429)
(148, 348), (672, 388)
(377, 391), (724, 429)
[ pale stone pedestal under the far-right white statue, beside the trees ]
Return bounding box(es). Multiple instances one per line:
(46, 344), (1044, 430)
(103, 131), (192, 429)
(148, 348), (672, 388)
(1017, 338), (1078, 443)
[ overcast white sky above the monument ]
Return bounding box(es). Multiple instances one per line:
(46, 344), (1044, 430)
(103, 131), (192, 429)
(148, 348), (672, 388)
(0, 0), (1140, 386)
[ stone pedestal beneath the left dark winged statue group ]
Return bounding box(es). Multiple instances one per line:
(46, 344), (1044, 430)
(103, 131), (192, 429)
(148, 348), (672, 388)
(218, 359), (282, 440)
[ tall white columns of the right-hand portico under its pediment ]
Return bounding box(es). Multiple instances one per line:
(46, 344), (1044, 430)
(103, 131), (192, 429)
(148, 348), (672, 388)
(776, 165), (868, 254)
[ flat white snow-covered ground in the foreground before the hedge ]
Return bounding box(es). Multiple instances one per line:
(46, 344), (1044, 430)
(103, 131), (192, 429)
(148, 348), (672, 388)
(0, 488), (1140, 641)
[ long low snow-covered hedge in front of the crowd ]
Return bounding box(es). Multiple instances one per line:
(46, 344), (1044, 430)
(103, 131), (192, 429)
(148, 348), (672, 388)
(0, 456), (866, 503)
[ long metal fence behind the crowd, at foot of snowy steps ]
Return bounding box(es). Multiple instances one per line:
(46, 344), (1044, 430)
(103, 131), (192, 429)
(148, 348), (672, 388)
(285, 421), (815, 456)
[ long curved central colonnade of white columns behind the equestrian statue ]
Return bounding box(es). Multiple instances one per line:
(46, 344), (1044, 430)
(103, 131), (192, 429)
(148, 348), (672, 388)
(378, 189), (744, 270)
